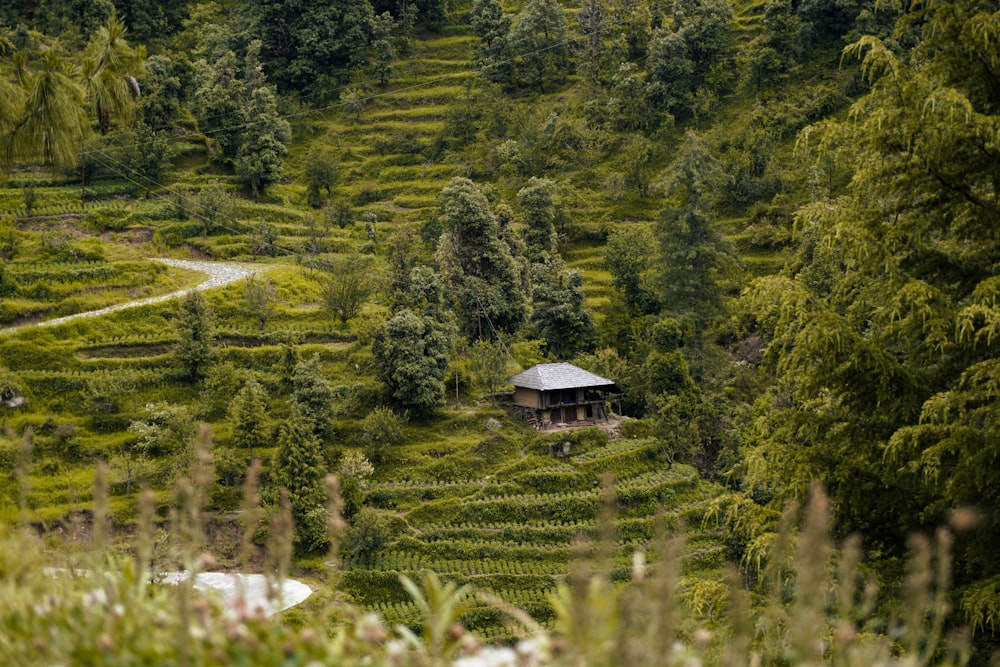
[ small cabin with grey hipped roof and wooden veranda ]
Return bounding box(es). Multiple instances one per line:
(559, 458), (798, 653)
(507, 362), (619, 428)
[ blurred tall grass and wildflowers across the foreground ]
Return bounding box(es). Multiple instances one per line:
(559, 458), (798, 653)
(0, 454), (972, 667)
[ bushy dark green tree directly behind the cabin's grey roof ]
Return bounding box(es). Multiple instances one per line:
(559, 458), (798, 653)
(531, 257), (597, 359)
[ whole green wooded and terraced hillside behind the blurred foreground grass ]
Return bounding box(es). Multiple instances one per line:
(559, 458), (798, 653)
(0, 0), (1000, 662)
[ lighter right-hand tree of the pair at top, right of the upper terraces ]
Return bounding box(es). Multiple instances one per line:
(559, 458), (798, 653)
(510, 0), (569, 90)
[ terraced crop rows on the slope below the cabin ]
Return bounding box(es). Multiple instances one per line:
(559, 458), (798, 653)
(340, 424), (724, 638)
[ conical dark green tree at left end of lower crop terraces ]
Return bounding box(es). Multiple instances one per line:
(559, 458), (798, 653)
(271, 409), (326, 549)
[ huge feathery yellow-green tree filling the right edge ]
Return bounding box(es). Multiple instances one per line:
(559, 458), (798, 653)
(745, 0), (1000, 627)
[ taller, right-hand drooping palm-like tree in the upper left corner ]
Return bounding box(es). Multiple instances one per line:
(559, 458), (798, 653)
(77, 14), (146, 135)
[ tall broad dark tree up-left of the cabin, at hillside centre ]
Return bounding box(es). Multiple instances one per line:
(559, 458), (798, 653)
(437, 178), (527, 339)
